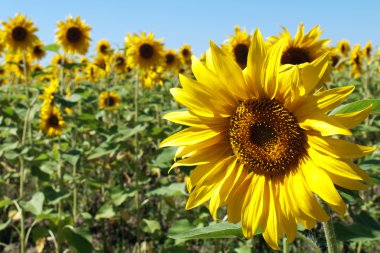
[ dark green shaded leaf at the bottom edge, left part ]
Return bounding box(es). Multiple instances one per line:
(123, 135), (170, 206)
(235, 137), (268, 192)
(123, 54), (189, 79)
(63, 226), (93, 253)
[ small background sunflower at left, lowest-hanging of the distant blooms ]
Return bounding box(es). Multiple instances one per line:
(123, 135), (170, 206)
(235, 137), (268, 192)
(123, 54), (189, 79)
(40, 105), (65, 137)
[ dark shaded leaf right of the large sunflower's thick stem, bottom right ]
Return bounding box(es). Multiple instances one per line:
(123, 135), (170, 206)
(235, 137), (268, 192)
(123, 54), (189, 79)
(334, 212), (380, 242)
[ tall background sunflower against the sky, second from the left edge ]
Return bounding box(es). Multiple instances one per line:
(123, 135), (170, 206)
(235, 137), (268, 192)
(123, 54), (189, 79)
(56, 16), (91, 55)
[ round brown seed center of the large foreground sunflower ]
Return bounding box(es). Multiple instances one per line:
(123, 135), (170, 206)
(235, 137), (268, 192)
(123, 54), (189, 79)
(229, 98), (307, 176)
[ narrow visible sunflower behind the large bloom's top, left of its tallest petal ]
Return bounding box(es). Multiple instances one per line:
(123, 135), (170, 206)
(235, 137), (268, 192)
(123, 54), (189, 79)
(225, 26), (251, 69)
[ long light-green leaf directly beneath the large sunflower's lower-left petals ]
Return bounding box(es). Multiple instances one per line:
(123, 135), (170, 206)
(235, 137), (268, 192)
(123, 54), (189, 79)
(169, 222), (254, 240)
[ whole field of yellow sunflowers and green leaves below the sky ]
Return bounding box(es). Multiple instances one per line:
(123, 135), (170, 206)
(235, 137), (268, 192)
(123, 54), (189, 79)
(0, 14), (380, 253)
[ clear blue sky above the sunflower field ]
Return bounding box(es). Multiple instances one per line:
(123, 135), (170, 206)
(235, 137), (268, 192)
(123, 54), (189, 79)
(0, 0), (380, 63)
